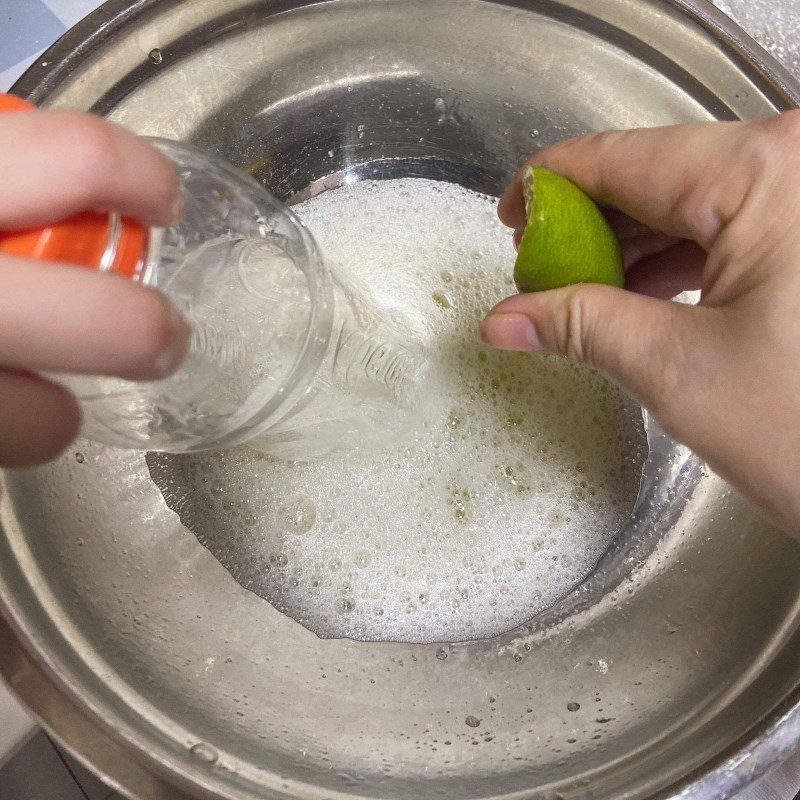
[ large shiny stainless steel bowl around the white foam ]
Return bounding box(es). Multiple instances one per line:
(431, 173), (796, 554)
(0, 0), (800, 800)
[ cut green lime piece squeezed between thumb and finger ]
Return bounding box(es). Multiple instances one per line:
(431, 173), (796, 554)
(514, 167), (624, 292)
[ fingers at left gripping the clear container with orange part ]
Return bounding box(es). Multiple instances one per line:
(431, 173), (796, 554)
(0, 111), (190, 467)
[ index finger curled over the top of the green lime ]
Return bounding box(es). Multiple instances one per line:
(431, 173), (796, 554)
(498, 116), (780, 249)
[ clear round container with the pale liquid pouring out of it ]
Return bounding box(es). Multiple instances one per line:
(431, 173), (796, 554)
(0, 131), (426, 460)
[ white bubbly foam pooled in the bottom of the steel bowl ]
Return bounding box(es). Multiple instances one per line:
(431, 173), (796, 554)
(148, 179), (646, 641)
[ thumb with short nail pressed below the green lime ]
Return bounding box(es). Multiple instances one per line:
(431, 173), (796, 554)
(480, 284), (714, 416)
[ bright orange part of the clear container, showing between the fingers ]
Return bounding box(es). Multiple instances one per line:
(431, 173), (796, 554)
(0, 93), (148, 278)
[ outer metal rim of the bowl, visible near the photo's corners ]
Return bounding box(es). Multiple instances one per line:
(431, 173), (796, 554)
(6, 0), (800, 800)
